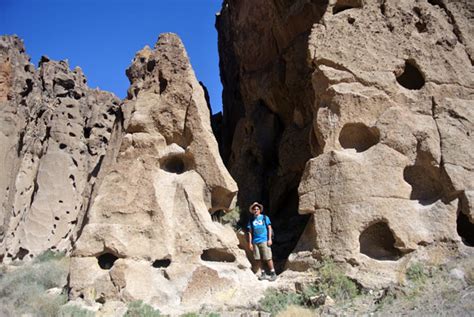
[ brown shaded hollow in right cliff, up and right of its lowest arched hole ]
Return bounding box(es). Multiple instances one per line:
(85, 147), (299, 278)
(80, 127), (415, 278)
(403, 165), (443, 205)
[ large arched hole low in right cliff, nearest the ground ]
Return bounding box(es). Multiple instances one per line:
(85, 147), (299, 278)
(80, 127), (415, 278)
(359, 222), (402, 261)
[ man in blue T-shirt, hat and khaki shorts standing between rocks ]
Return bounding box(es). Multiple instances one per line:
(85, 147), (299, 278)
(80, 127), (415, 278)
(247, 202), (276, 281)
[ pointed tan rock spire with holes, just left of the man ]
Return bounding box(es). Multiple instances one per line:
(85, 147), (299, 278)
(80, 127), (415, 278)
(70, 34), (255, 313)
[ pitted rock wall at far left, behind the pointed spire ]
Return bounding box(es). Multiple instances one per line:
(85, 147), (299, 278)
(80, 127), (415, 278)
(0, 36), (120, 262)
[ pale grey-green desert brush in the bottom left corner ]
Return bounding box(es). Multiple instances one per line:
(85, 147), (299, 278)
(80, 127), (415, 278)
(0, 252), (68, 316)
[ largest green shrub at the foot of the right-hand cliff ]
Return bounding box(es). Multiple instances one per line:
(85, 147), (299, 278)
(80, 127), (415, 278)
(304, 259), (360, 300)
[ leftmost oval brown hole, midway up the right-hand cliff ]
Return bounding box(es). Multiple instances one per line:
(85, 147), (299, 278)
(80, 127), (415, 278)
(339, 123), (380, 152)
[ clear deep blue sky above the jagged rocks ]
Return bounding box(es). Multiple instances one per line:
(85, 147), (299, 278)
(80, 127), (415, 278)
(0, 0), (222, 113)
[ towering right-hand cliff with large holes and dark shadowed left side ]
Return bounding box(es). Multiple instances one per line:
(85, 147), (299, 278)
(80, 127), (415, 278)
(217, 0), (474, 286)
